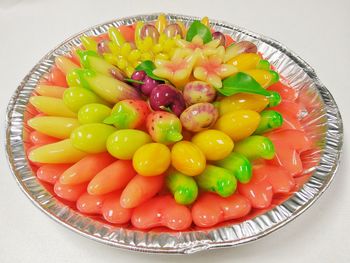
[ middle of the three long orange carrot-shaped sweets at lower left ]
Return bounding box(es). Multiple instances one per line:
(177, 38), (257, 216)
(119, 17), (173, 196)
(88, 160), (136, 195)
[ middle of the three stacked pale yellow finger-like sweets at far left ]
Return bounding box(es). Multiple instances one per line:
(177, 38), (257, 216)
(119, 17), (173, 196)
(28, 116), (80, 139)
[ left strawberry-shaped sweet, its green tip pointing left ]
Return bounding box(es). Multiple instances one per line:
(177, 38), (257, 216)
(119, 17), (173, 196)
(104, 100), (150, 129)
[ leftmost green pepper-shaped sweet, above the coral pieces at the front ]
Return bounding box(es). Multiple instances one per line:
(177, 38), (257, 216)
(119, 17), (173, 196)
(166, 171), (198, 205)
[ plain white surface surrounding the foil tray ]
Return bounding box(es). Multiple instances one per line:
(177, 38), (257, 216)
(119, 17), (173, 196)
(0, 0), (350, 263)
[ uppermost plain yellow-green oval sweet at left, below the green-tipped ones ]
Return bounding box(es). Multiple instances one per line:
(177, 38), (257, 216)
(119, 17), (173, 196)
(63, 87), (108, 112)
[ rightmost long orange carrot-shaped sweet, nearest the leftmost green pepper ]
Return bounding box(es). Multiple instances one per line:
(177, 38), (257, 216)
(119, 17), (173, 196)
(120, 174), (164, 208)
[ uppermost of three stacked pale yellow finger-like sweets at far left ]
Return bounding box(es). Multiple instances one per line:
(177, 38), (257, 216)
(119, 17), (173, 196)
(29, 96), (77, 118)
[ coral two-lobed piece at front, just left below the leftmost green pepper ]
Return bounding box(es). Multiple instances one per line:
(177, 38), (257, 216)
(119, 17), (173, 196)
(131, 195), (192, 231)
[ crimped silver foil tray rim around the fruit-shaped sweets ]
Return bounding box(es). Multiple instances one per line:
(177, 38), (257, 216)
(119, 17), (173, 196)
(6, 14), (343, 254)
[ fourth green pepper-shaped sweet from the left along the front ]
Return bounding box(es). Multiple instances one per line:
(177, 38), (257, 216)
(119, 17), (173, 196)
(234, 135), (275, 161)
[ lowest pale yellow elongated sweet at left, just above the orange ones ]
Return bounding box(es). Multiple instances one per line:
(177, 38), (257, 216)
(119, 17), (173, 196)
(28, 139), (87, 163)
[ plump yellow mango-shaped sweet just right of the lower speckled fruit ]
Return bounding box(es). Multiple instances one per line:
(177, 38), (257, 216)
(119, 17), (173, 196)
(214, 110), (260, 141)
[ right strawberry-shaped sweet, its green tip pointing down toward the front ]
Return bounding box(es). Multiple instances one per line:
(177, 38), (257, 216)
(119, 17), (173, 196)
(147, 111), (182, 144)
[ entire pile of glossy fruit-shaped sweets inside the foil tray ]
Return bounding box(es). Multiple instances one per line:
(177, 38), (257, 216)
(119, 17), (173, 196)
(24, 15), (311, 230)
